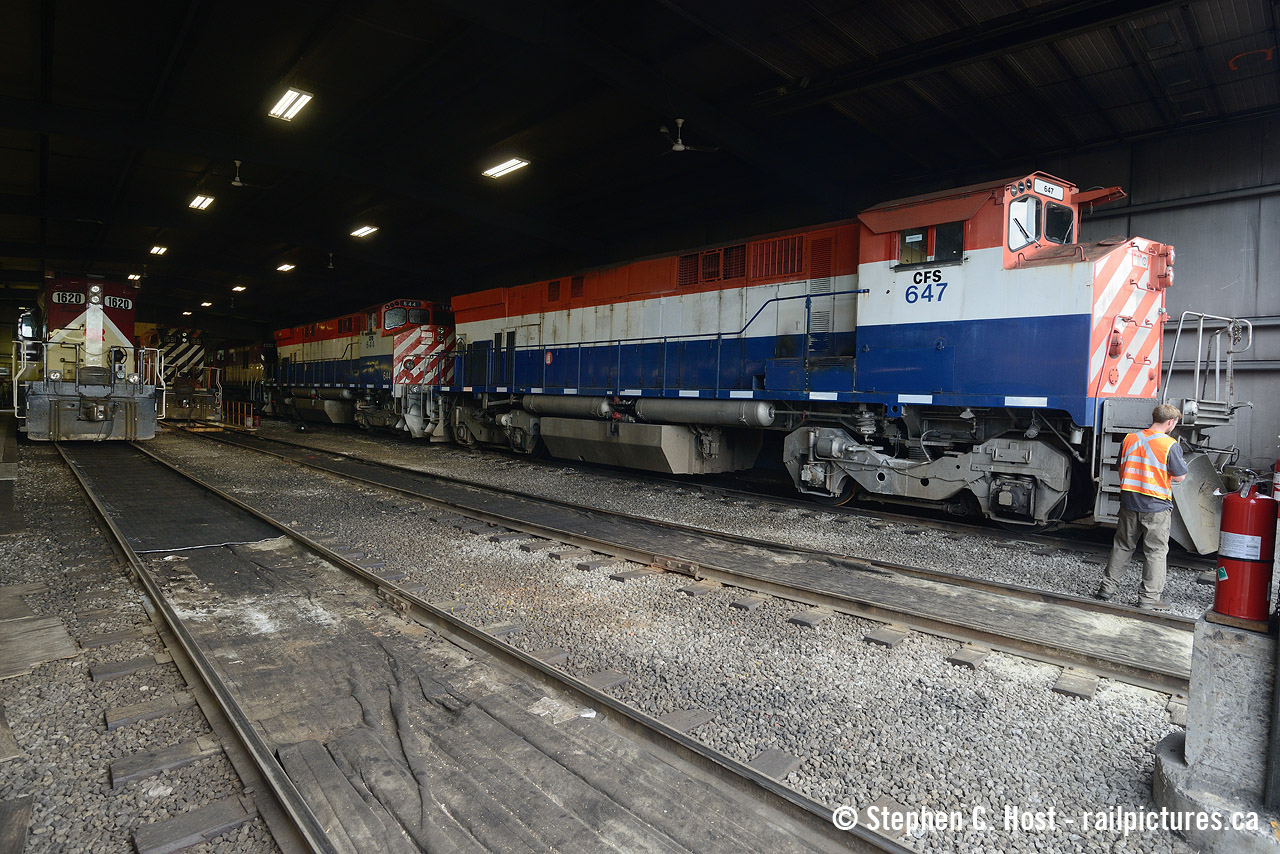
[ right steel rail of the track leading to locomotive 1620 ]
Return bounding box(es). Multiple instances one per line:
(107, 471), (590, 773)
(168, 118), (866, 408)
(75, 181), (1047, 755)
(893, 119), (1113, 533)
(122, 443), (914, 854)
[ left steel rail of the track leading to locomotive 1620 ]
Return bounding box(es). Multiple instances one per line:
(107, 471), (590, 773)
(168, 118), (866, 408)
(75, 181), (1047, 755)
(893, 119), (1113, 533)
(55, 443), (339, 854)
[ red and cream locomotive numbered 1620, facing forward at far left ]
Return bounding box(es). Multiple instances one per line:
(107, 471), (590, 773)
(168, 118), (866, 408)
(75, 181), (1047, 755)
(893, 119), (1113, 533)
(13, 278), (164, 442)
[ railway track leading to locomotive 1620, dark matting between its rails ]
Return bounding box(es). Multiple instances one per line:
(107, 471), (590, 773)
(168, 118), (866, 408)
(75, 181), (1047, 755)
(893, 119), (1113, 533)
(60, 444), (910, 851)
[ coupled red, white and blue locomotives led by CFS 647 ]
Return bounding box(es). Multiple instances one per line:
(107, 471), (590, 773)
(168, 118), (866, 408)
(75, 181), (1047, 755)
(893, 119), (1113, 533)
(222, 172), (1252, 552)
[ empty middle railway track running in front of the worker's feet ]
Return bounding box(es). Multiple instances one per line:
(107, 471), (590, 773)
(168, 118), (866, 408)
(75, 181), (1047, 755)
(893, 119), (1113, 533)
(175, 425), (1194, 694)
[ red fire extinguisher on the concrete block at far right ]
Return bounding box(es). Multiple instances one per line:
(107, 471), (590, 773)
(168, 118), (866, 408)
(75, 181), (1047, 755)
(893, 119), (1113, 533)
(1213, 484), (1276, 621)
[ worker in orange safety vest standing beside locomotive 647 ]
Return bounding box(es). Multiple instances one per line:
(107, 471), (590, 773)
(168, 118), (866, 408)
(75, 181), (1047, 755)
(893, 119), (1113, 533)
(1096, 403), (1187, 611)
